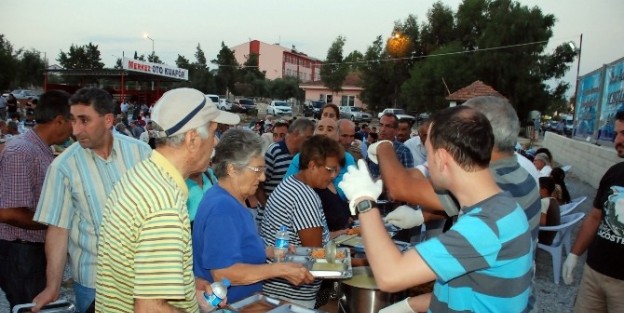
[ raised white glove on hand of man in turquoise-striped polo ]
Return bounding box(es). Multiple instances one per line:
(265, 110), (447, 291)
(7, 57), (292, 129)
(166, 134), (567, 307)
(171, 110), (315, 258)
(338, 159), (383, 215)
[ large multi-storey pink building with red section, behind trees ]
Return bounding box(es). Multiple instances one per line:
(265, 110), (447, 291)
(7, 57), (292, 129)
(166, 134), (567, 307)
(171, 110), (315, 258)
(230, 40), (322, 82)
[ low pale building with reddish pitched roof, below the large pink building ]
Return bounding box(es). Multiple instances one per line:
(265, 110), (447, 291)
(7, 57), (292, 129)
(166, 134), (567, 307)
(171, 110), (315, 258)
(299, 72), (367, 109)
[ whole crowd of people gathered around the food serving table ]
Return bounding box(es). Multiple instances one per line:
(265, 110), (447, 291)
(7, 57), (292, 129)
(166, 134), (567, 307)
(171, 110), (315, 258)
(0, 88), (624, 313)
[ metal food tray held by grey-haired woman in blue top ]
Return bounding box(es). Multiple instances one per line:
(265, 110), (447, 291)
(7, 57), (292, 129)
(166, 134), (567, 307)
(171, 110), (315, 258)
(285, 247), (353, 279)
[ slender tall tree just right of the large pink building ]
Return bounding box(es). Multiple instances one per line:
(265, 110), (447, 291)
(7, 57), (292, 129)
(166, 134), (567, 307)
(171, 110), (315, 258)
(321, 36), (349, 92)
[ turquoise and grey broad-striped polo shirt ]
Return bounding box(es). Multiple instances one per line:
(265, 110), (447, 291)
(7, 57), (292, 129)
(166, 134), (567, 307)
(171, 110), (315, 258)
(416, 193), (533, 313)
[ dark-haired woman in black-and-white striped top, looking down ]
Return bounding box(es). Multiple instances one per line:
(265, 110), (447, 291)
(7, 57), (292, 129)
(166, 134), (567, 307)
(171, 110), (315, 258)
(260, 135), (344, 308)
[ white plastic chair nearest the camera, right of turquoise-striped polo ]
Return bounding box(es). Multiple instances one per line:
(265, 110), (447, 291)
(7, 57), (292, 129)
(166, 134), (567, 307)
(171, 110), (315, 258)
(537, 213), (585, 284)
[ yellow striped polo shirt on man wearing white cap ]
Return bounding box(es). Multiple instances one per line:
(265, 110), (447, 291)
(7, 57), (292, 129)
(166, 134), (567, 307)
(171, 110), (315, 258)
(95, 151), (199, 312)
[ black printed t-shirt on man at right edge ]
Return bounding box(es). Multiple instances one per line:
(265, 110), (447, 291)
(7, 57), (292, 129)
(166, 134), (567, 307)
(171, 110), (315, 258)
(587, 162), (624, 280)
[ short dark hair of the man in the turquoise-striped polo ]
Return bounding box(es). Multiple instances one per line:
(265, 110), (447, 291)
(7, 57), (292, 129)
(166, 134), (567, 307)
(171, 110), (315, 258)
(428, 106), (494, 172)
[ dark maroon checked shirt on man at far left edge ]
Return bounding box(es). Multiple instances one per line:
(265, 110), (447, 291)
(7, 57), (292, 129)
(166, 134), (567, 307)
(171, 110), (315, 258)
(0, 130), (54, 242)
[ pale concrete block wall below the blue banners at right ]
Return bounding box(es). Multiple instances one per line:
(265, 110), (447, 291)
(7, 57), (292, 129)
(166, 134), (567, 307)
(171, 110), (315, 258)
(542, 132), (624, 188)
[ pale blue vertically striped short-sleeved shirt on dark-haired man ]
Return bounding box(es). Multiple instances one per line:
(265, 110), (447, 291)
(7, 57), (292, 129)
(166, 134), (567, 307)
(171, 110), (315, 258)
(33, 134), (151, 288)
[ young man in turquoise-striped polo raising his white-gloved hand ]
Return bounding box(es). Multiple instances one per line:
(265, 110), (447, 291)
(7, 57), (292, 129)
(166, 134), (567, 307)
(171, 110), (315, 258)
(341, 106), (533, 312)
